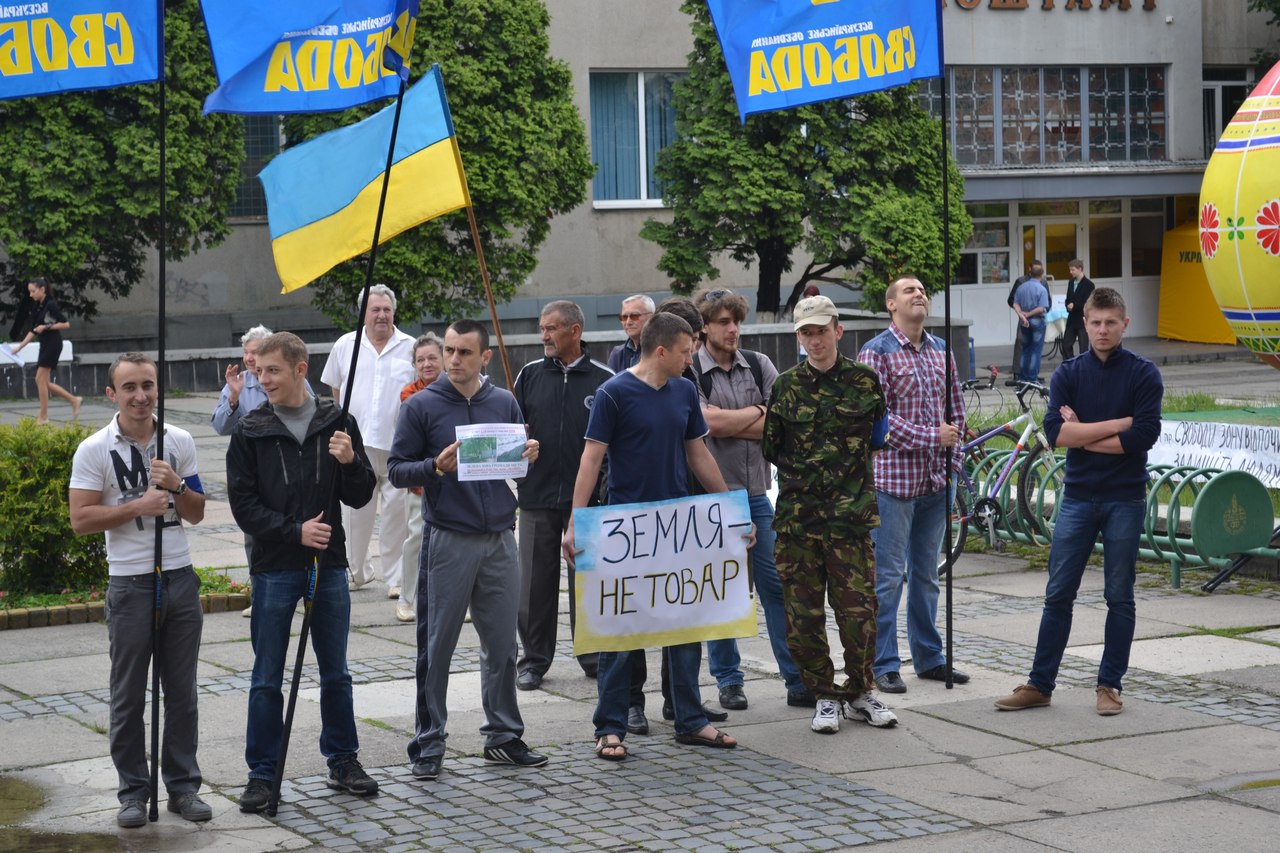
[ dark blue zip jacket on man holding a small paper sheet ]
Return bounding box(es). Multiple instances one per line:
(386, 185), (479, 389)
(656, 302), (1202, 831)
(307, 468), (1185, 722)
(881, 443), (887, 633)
(387, 377), (525, 533)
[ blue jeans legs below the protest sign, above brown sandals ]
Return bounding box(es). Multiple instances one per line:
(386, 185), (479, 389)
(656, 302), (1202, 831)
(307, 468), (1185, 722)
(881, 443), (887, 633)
(591, 643), (707, 738)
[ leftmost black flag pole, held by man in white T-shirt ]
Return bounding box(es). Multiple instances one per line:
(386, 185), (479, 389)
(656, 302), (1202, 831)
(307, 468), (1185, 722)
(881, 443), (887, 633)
(147, 0), (168, 824)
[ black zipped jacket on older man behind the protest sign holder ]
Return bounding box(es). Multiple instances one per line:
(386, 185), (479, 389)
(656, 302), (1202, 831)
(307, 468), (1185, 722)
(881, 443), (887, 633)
(515, 346), (613, 510)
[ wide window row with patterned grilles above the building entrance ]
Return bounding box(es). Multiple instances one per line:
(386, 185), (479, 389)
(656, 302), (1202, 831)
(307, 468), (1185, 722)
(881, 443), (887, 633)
(920, 65), (1167, 167)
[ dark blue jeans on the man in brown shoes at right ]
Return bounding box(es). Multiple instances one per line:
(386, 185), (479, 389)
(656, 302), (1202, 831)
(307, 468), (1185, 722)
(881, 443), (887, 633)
(1028, 498), (1147, 693)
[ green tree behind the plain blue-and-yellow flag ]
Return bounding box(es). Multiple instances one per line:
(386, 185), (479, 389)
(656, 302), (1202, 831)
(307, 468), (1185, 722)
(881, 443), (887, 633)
(285, 0), (595, 325)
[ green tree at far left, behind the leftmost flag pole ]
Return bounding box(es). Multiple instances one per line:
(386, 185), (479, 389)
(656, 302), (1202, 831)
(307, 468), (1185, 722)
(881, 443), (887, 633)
(0, 0), (244, 318)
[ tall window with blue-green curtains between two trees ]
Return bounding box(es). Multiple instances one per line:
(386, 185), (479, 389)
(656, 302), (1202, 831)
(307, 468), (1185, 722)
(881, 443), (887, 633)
(590, 72), (684, 206)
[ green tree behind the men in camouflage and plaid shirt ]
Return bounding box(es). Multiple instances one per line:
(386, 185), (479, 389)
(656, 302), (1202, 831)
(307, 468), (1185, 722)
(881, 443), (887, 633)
(640, 0), (972, 311)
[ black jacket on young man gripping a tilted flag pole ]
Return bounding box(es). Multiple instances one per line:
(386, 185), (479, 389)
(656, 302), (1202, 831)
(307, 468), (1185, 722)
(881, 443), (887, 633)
(227, 398), (376, 575)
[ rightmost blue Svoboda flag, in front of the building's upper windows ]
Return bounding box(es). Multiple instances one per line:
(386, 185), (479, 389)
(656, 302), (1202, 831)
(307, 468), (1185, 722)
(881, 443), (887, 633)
(707, 0), (943, 122)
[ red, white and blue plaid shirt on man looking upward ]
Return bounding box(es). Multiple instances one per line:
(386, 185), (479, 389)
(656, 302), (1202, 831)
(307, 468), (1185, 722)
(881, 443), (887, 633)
(858, 323), (964, 498)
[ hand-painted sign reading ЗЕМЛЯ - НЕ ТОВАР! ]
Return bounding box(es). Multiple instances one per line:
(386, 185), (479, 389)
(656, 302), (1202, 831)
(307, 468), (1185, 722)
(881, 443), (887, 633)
(573, 489), (756, 654)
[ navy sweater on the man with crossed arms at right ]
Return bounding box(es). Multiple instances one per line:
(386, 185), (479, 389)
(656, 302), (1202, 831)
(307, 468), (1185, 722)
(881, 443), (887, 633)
(1044, 346), (1165, 501)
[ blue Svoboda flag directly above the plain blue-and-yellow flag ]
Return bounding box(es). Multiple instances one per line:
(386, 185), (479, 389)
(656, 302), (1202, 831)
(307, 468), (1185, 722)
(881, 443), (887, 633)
(199, 0), (417, 114)
